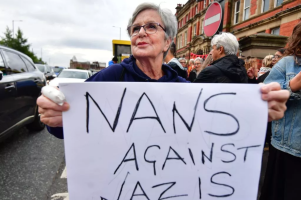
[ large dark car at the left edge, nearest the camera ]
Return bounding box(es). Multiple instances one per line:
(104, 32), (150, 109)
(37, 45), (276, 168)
(0, 45), (46, 141)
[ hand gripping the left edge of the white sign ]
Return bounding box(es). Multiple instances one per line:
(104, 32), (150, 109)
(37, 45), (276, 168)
(37, 95), (69, 127)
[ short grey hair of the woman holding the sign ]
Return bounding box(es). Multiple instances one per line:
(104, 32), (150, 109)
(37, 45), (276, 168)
(128, 3), (178, 40)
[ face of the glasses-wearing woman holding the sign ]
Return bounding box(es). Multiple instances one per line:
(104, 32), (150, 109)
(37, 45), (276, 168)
(131, 10), (171, 60)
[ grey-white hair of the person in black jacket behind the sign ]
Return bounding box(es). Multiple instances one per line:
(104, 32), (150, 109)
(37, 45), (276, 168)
(211, 32), (239, 55)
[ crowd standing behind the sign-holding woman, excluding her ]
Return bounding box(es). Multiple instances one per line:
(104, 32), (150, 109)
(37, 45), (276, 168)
(165, 22), (301, 200)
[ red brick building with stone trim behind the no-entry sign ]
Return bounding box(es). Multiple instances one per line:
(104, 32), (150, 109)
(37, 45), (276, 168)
(176, 0), (301, 59)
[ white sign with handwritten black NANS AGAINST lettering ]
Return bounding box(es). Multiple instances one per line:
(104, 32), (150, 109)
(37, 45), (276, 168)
(60, 82), (267, 200)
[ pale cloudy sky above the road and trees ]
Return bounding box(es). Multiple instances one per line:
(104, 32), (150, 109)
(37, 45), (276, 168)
(0, 0), (188, 67)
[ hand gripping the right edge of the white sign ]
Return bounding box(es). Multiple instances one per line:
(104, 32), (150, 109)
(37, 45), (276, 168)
(261, 82), (289, 122)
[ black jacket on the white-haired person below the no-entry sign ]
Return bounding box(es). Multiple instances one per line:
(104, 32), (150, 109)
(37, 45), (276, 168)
(194, 55), (248, 83)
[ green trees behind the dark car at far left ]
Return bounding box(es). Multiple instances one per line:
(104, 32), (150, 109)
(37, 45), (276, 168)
(0, 27), (45, 64)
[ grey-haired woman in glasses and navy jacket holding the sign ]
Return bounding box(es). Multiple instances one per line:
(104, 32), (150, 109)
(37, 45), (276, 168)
(37, 3), (288, 138)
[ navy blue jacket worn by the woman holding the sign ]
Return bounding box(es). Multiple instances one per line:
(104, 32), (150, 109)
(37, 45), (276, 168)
(47, 56), (188, 139)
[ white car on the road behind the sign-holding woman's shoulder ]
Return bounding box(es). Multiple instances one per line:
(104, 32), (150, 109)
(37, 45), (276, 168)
(49, 69), (92, 87)
